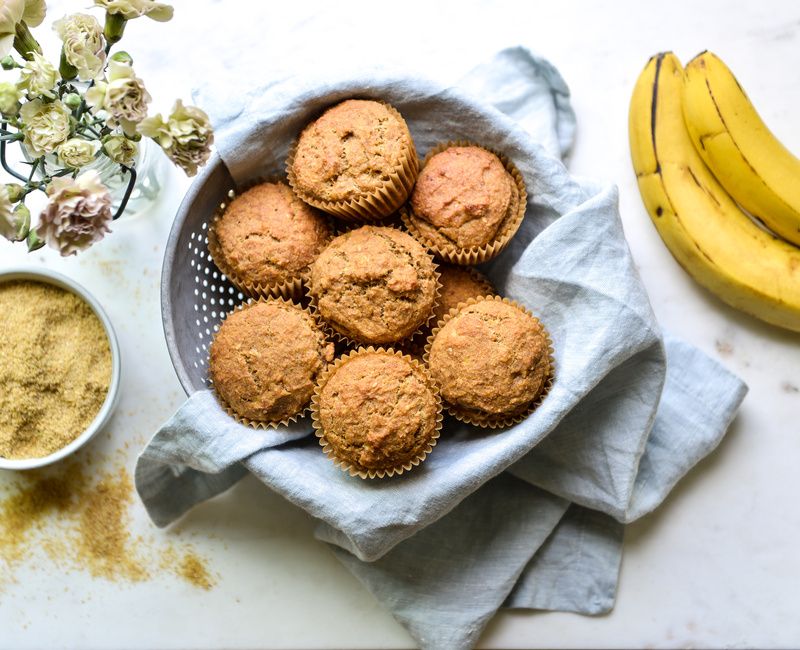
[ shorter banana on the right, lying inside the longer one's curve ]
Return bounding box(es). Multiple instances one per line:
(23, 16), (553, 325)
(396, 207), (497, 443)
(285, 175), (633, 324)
(683, 52), (800, 244)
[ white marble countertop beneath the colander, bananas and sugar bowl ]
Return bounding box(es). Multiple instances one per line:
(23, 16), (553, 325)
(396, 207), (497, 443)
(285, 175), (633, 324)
(0, 0), (800, 648)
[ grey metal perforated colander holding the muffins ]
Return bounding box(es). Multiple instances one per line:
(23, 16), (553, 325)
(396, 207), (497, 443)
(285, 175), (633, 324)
(161, 154), (245, 395)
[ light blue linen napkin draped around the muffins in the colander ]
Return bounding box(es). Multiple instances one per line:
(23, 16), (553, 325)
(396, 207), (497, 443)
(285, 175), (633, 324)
(135, 48), (746, 648)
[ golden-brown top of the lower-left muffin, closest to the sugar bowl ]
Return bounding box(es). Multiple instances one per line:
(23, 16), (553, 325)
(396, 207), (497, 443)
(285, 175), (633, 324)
(209, 300), (333, 423)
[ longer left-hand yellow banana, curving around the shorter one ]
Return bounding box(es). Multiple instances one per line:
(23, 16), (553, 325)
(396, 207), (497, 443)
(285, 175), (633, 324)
(629, 53), (800, 331)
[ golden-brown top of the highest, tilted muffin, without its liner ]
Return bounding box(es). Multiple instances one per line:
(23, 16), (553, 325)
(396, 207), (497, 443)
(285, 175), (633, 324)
(292, 99), (416, 201)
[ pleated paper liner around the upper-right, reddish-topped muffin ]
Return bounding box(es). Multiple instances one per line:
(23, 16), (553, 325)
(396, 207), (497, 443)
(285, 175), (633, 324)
(400, 140), (528, 266)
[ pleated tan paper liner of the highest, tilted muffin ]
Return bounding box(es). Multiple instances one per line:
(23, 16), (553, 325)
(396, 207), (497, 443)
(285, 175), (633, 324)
(286, 99), (419, 224)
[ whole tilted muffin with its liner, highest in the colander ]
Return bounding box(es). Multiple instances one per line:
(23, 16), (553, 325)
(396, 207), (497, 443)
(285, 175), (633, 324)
(287, 99), (419, 220)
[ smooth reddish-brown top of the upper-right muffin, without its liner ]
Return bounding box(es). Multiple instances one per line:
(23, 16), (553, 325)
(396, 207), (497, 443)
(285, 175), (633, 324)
(411, 146), (519, 248)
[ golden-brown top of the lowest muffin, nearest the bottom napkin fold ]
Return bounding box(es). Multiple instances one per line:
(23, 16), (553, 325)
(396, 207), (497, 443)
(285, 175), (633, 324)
(318, 350), (440, 470)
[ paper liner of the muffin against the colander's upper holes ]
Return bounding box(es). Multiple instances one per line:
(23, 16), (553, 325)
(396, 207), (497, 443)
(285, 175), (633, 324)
(208, 176), (336, 300)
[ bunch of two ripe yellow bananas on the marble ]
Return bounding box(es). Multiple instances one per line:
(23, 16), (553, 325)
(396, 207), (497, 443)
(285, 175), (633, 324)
(629, 52), (800, 332)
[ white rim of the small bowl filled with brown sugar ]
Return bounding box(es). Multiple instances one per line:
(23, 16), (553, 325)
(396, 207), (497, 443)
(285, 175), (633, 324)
(0, 268), (120, 470)
